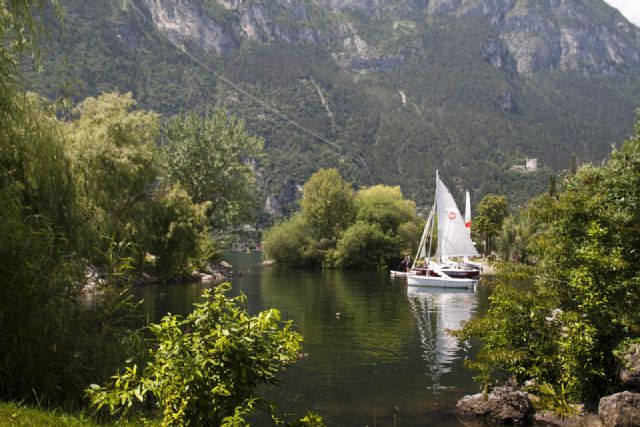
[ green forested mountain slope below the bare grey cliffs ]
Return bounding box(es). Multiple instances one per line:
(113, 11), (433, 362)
(23, 0), (640, 214)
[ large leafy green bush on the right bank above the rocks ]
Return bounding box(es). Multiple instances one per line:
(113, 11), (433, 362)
(458, 132), (640, 412)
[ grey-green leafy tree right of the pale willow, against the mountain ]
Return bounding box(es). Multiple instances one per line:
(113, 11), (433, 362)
(162, 110), (263, 227)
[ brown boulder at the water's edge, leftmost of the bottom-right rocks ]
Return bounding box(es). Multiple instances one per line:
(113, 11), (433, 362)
(456, 387), (532, 424)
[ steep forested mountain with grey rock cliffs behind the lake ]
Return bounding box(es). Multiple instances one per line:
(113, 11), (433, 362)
(24, 0), (640, 214)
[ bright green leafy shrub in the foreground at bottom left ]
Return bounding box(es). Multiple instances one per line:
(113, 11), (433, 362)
(87, 284), (302, 425)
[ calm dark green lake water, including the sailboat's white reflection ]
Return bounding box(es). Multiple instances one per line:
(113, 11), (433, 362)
(137, 253), (496, 426)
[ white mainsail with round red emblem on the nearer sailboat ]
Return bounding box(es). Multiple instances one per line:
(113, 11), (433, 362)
(436, 176), (478, 258)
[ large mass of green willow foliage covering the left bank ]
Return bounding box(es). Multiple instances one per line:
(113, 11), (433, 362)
(0, 0), (264, 414)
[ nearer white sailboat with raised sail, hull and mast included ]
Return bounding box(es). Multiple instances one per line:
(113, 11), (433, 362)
(406, 172), (480, 288)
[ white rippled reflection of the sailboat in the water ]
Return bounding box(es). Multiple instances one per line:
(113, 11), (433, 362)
(407, 286), (477, 390)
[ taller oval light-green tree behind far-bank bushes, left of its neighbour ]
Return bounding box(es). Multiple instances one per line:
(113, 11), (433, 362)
(300, 168), (355, 242)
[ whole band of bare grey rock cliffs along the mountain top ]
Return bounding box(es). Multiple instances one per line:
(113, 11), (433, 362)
(144, 0), (640, 75)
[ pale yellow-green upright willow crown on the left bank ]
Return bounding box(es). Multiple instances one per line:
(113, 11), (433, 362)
(66, 93), (158, 256)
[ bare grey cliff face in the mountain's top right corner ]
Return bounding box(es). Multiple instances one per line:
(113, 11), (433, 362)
(484, 0), (640, 75)
